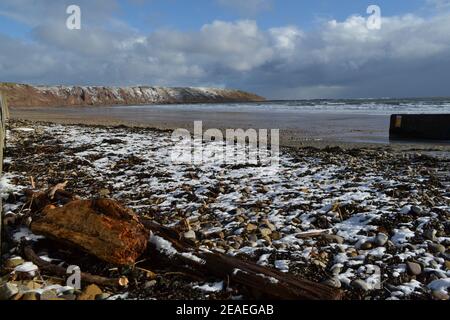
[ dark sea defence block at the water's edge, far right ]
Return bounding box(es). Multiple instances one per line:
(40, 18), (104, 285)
(389, 114), (450, 141)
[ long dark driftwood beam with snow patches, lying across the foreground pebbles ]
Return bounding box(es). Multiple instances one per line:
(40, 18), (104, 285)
(140, 218), (342, 300)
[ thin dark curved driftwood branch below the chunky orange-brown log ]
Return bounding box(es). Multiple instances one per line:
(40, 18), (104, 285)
(23, 246), (124, 288)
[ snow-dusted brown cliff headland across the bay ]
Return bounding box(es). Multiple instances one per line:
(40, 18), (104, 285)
(0, 83), (264, 107)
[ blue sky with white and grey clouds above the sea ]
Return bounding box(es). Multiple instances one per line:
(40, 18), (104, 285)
(0, 0), (450, 99)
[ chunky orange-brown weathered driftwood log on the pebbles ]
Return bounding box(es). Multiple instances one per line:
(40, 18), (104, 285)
(30, 199), (149, 265)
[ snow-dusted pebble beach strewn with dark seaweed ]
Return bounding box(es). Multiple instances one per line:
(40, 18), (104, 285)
(1, 119), (450, 299)
